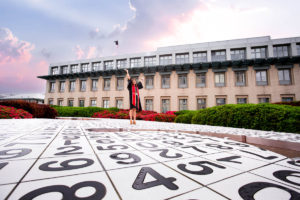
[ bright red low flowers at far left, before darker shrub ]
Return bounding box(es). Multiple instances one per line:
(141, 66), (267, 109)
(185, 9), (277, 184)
(0, 105), (32, 119)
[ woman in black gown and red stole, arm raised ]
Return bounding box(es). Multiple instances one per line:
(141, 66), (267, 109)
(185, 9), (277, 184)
(125, 69), (143, 124)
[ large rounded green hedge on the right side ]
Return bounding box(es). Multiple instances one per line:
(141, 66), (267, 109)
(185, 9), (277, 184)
(190, 103), (300, 133)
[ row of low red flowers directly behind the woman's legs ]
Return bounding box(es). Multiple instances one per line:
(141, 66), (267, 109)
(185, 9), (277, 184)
(92, 109), (176, 122)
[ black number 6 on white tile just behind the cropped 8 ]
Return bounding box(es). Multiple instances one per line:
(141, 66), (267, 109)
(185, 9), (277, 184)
(39, 158), (94, 171)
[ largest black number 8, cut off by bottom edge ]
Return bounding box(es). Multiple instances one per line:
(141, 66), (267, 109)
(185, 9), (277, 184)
(20, 181), (106, 200)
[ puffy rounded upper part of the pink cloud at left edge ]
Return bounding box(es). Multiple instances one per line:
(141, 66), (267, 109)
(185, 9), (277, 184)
(0, 28), (34, 64)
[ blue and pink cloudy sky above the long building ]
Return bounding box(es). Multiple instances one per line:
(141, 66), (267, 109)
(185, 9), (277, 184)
(0, 0), (300, 94)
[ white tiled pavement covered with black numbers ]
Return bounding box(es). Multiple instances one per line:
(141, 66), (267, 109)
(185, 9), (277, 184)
(0, 119), (300, 200)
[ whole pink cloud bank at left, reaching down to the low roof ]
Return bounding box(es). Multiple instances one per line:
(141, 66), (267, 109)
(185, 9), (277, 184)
(0, 28), (49, 93)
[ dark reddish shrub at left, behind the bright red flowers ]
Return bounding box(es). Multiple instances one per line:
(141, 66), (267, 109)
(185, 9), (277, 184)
(0, 100), (58, 118)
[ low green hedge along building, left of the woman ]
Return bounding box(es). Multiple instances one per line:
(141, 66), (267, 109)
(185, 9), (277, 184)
(52, 106), (119, 117)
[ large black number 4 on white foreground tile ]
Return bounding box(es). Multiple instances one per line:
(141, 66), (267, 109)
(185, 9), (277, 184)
(132, 167), (178, 190)
